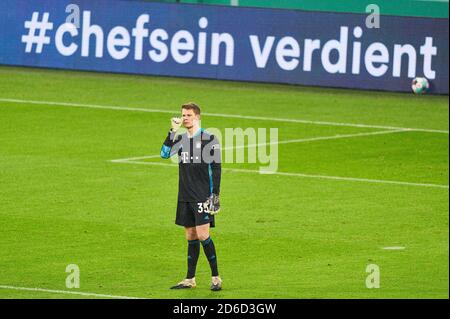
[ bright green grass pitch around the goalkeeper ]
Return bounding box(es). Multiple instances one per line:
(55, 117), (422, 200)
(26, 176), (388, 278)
(0, 67), (449, 298)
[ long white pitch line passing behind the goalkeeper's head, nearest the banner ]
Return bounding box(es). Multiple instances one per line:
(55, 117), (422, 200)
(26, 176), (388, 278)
(0, 98), (449, 134)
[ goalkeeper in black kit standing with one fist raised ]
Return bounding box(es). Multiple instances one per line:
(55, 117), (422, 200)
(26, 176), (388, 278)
(161, 103), (222, 291)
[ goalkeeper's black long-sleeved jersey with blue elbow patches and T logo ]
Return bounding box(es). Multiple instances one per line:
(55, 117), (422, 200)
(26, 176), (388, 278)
(161, 129), (221, 203)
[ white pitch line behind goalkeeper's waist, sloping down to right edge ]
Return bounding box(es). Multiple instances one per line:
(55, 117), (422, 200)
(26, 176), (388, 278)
(111, 160), (448, 189)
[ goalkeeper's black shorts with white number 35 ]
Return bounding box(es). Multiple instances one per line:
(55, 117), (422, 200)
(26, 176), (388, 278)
(175, 202), (215, 227)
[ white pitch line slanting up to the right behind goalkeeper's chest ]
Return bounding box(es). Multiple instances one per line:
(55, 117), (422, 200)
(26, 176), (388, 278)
(111, 129), (410, 162)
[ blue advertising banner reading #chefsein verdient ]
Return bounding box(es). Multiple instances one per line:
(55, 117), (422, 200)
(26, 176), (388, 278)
(0, 0), (449, 94)
